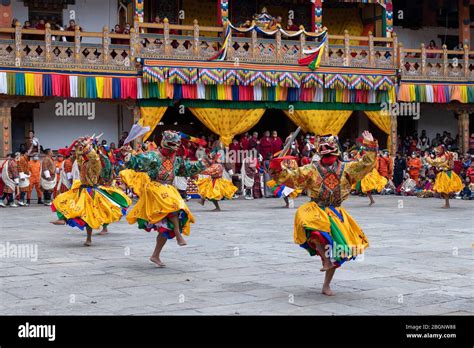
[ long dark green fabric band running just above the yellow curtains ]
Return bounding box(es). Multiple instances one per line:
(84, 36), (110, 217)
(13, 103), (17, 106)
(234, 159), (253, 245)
(139, 98), (386, 111)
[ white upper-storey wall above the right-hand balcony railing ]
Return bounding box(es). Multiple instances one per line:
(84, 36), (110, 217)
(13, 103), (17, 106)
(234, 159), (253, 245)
(394, 27), (474, 49)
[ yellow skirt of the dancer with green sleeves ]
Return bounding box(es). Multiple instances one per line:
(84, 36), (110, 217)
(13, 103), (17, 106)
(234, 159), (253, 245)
(127, 181), (194, 239)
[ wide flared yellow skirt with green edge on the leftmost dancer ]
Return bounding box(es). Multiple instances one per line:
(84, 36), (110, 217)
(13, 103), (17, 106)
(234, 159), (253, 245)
(51, 180), (132, 229)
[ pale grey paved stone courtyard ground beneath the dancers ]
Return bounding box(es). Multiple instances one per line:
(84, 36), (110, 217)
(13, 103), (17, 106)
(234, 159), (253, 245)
(0, 196), (474, 315)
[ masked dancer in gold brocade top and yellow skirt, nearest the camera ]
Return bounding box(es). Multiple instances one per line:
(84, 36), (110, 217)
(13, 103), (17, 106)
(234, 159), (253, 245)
(272, 131), (378, 296)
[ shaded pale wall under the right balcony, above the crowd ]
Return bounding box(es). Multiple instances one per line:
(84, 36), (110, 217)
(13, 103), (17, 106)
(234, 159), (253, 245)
(418, 104), (458, 139)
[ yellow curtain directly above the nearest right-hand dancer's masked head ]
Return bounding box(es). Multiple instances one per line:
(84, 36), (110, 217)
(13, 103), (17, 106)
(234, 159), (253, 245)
(285, 110), (352, 135)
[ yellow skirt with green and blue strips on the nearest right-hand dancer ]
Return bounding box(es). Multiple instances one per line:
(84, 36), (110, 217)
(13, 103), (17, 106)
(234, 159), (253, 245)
(293, 202), (369, 267)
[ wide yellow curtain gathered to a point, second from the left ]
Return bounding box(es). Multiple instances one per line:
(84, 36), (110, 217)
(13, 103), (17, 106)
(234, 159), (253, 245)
(190, 108), (265, 146)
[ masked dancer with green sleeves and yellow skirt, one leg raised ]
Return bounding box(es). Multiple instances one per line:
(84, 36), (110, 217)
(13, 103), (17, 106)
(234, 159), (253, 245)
(121, 131), (208, 267)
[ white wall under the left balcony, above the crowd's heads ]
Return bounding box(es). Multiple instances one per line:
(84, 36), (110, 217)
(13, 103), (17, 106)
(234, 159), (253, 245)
(33, 99), (133, 150)
